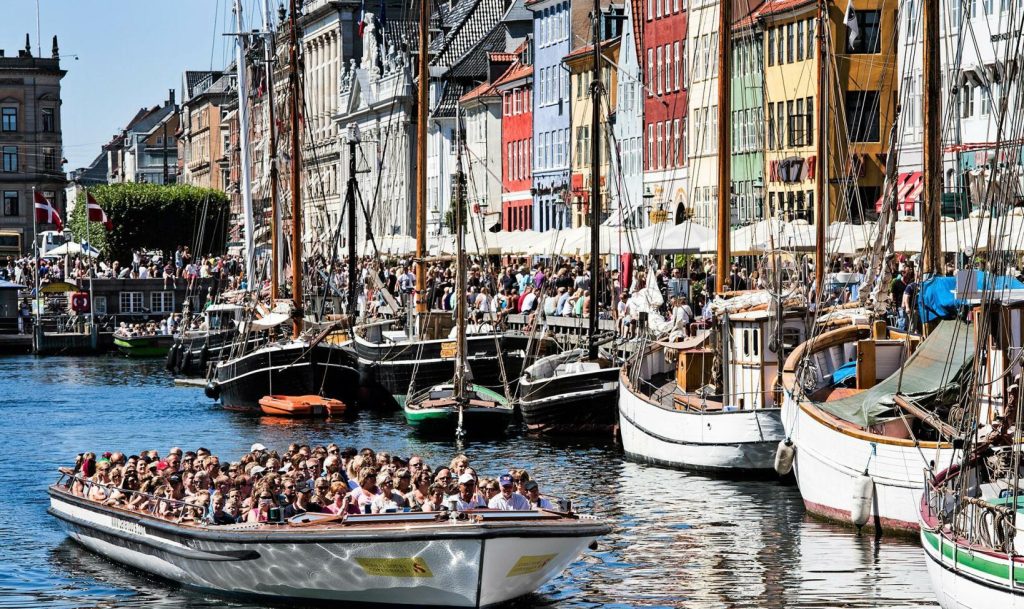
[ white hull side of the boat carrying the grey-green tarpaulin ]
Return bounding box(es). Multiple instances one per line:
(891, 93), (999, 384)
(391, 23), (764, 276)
(782, 391), (953, 534)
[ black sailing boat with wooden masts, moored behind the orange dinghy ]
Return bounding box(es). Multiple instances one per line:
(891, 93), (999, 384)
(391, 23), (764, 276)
(206, 1), (360, 411)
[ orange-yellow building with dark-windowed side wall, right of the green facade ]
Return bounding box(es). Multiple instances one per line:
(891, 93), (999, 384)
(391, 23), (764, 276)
(759, 0), (898, 223)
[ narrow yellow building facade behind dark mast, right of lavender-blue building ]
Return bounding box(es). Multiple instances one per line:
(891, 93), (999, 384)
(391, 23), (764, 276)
(563, 38), (621, 227)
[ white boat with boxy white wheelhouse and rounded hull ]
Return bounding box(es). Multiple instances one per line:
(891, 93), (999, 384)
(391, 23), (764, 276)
(618, 306), (804, 477)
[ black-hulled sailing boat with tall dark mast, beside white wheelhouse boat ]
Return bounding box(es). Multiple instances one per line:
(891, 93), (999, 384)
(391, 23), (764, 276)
(519, 1), (620, 435)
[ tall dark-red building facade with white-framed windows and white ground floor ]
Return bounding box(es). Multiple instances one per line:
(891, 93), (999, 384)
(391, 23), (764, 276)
(636, 0), (687, 220)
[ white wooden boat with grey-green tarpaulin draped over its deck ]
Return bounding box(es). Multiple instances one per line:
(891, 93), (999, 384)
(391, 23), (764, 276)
(780, 320), (975, 533)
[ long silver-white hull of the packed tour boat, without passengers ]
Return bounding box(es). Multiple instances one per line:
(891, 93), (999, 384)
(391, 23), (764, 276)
(48, 476), (610, 607)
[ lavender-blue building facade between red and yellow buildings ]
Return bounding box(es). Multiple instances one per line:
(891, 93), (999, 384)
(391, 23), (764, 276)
(526, 0), (571, 231)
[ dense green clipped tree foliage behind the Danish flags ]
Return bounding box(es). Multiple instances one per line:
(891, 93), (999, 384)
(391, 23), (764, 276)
(68, 182), (228, 260)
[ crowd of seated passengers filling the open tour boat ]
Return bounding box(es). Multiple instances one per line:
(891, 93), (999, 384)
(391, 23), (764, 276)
(61, 443), (556, 524)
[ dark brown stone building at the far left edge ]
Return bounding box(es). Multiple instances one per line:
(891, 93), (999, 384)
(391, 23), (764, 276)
(0, 35), (67, 251)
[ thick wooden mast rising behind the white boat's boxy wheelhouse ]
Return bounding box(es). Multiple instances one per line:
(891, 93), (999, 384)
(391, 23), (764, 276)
(715, 0), (732, 293)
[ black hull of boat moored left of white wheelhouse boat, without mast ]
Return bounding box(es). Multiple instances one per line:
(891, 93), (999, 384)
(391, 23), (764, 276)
(519, 349), (618, 436)
